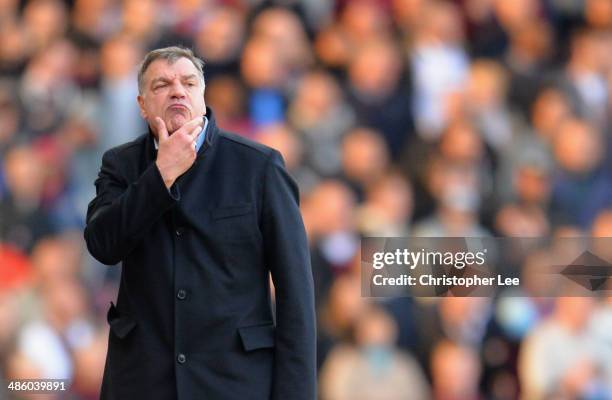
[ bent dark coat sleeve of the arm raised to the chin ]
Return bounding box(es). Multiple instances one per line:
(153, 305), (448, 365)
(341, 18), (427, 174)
(85, 149), (180, 265)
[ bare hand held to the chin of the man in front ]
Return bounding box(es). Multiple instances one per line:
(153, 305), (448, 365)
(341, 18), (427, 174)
(155, 116), (204, 188)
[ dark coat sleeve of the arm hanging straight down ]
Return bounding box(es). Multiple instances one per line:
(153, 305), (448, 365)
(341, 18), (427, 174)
(262, 151), (316, 400)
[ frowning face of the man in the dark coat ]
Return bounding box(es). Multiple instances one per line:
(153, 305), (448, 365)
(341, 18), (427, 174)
(138, 58), (206, 134)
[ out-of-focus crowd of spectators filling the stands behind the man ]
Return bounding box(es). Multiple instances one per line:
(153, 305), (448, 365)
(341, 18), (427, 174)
(0, 0), (612, 400)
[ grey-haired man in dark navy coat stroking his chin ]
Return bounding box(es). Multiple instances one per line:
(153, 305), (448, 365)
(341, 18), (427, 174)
(85, 47), (315, 400)
